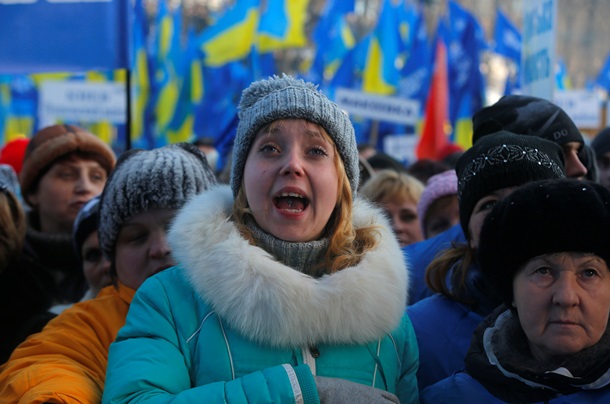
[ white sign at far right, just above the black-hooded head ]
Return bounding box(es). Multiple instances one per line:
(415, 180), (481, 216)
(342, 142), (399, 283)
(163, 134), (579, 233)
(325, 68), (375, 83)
(553, 90), (602, 129)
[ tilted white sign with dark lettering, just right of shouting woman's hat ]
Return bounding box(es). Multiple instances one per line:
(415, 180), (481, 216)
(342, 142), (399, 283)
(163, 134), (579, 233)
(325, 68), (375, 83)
(335, 88), (420, 125)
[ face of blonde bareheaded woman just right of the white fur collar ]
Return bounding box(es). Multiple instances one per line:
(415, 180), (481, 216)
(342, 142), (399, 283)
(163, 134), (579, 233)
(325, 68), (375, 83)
(380, 198), (424, 247)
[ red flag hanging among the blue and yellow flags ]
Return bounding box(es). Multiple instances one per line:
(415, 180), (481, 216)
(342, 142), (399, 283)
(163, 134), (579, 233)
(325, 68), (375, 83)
(416, 39), (450, 160)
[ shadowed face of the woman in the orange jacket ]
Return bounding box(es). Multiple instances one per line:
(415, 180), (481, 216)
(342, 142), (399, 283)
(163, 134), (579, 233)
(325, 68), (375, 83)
(114, 209), (176, 289)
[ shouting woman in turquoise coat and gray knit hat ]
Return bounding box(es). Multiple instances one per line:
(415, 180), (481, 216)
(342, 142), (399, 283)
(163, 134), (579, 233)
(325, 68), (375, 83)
(104, 76), (418, 403)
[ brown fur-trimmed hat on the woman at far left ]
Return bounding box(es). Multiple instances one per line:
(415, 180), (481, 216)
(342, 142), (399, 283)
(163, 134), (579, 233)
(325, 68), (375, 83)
(19, 125), (116, 205)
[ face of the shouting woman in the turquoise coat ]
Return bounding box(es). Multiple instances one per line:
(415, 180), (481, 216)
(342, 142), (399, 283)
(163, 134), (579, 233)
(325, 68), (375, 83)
(244, 119), (339, 242)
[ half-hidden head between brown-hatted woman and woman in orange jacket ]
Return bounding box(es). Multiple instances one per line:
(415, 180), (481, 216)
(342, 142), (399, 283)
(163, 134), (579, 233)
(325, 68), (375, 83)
(72, 196), (112, 296)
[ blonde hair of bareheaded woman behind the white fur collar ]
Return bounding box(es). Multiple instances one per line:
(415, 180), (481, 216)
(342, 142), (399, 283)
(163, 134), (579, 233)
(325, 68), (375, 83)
(359, 170), (424, 203)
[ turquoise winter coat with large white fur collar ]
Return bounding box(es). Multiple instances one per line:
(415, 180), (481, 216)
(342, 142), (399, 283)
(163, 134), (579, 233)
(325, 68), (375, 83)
(103, 187), (418, 403)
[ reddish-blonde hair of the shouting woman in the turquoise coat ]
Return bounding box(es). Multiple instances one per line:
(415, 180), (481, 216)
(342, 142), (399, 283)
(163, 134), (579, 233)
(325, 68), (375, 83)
(232, 120), (380, 273)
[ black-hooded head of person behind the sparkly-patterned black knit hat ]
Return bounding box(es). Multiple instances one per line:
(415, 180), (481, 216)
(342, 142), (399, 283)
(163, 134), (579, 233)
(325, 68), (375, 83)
(472, 95), (587, 179)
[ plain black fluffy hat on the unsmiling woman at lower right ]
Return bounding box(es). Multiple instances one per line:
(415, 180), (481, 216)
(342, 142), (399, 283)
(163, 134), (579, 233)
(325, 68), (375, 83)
(477, 179), (610, 305)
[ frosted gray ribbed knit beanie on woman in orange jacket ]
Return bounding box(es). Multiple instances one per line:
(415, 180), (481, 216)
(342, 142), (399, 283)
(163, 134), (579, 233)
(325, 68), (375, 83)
(98, 143), (216, 259)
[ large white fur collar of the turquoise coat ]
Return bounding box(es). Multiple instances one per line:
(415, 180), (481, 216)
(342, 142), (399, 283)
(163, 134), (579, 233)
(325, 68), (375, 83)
(169, 186), (408, 347)
